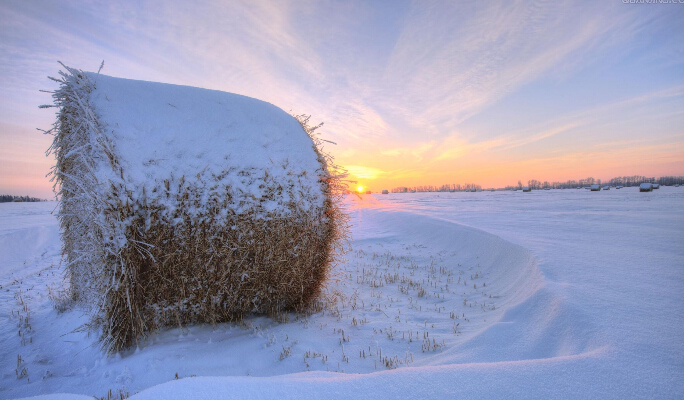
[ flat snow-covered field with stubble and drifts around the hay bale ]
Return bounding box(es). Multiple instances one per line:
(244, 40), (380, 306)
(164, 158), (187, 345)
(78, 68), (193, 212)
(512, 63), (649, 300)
(0, 187), (684, 399)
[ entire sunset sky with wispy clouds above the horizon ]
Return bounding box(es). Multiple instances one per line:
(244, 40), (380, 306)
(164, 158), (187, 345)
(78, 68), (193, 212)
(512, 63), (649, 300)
(0, 0), (684, 197)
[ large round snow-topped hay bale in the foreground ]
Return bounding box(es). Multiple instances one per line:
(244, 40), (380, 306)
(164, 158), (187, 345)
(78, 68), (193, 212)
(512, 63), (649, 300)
(44, 66), (346, 352)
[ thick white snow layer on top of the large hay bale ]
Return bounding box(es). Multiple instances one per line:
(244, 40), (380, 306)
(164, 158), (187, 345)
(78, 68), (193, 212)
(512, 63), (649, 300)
(86, 73), (324, 213)
